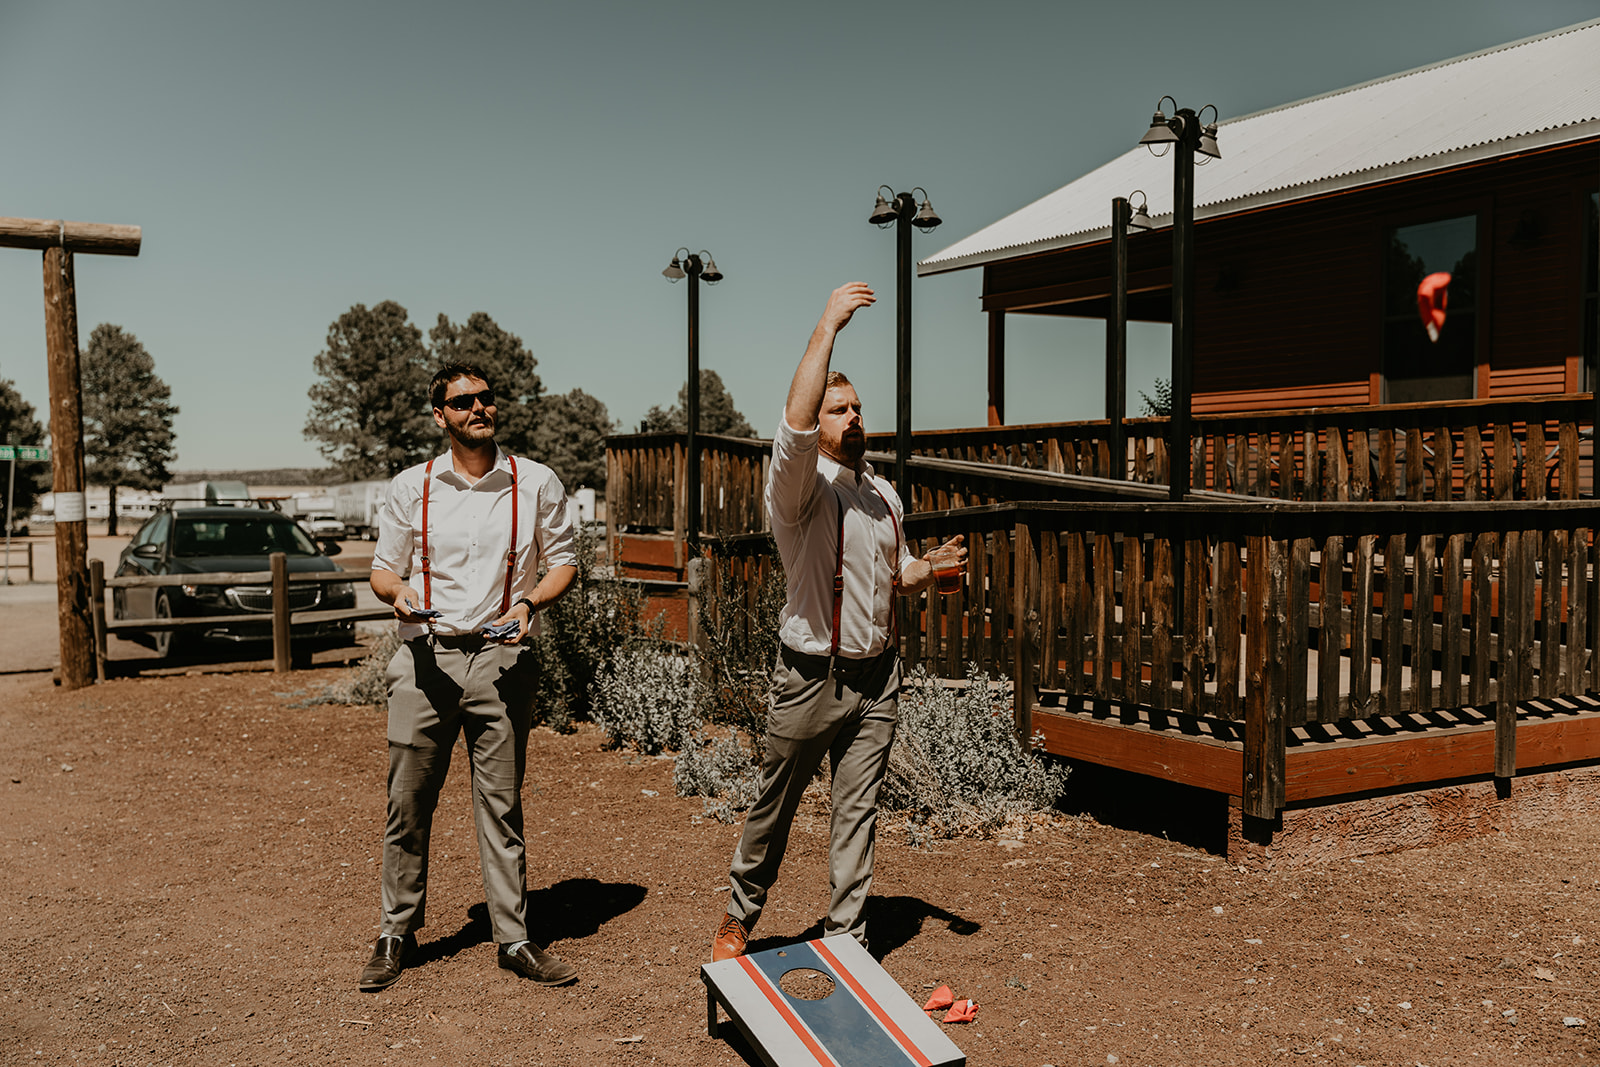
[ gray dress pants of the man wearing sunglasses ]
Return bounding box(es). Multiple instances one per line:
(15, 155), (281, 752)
(381, 637), (536, 944)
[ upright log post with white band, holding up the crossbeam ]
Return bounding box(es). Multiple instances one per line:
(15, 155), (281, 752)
(45, 246), (94, 689)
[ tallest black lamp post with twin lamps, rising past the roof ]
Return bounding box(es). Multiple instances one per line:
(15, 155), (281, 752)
(1139, 96), (1222, 501)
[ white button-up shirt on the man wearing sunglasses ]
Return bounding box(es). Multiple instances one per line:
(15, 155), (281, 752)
(373, 451), (578, 640)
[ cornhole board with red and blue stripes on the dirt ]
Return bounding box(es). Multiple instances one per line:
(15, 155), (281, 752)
(701, 934), (966, 1067)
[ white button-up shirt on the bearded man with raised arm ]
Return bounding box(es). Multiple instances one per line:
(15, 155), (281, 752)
(766, 419), (912, 659)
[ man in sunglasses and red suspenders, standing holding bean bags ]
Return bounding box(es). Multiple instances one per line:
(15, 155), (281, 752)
(358, 363), (578, 992)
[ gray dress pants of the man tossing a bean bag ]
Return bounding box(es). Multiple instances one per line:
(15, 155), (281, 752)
(728, 646), (901, 942)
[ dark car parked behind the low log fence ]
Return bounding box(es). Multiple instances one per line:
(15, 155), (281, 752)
(112, 507), (355, 657)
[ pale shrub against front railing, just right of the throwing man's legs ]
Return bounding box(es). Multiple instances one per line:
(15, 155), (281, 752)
(878, 665), (1067, 838)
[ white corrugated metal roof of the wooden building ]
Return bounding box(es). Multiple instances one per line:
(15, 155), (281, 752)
(917, 19), (1600, 275)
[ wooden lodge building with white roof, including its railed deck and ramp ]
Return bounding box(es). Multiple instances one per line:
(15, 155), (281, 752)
(606, 21), (1600, 859)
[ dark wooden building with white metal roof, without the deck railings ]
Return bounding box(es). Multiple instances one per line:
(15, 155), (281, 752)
(918, 21), (1600, 413)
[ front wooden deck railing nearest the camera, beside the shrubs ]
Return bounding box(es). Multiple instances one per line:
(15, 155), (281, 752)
(697, 499), (1600, 817)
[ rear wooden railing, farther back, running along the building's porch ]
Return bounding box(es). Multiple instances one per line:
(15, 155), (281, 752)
(606, 394), (1594, 536)
